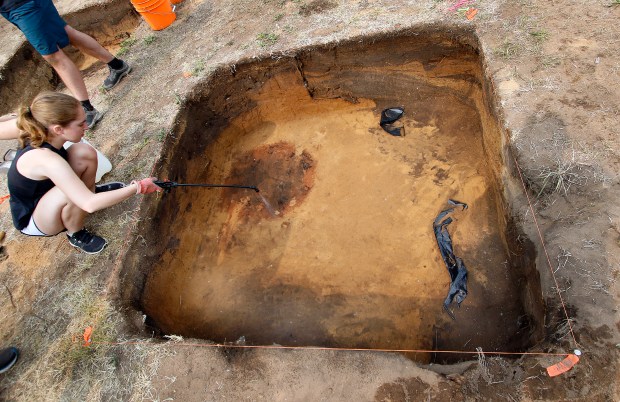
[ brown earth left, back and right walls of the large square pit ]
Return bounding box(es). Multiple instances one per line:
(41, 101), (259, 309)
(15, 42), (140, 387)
(121, 27), (544, 345)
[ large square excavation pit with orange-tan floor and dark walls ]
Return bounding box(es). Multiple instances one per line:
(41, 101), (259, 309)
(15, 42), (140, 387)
(122, 30), (544, 362)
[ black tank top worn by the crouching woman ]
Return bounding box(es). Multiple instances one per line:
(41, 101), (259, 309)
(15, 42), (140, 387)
(7, 142), (67, 230)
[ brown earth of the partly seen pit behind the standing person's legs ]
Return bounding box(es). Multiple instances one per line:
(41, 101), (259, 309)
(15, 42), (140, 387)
(0, 0), (140, 115)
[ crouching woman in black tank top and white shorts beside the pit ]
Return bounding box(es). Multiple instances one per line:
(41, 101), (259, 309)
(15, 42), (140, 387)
(8, 92), (160, 254)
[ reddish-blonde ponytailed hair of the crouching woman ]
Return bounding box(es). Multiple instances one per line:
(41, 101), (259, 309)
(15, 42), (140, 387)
(17, 92), (80, 148)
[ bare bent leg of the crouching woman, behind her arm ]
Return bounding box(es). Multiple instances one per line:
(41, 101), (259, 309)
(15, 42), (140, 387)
(33, 143), (97, 235)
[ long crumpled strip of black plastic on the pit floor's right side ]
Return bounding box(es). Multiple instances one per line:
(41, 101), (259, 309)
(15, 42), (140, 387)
(433, 200), (467, 320)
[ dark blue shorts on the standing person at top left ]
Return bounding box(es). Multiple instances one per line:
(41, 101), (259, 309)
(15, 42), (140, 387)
(2, 0), (69, 56)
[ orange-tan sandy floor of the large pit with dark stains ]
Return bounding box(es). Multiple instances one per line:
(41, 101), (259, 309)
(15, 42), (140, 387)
(142, 74), (527, 359)
